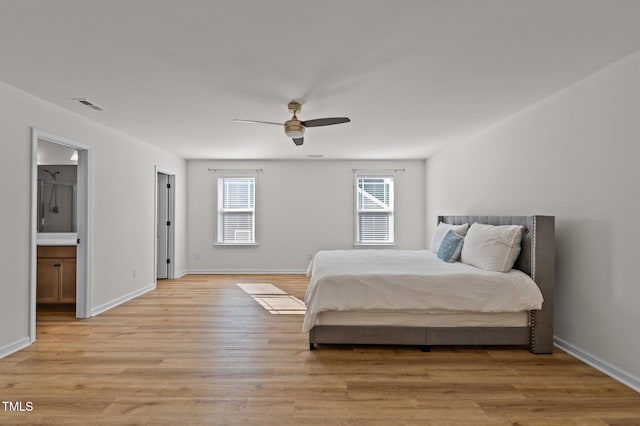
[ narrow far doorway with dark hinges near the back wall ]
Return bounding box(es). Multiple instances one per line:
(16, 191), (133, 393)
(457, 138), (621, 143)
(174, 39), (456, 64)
(155, 167), (175, 281)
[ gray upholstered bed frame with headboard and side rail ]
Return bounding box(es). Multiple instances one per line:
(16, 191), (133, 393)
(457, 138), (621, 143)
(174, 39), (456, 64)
(309, 216), (555, 354)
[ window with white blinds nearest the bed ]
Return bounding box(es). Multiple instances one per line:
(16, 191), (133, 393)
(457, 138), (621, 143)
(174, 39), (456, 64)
(355, 175), (394, 244)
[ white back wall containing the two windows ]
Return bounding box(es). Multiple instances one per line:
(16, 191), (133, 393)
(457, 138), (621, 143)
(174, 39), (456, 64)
(187, 160), (425, 273)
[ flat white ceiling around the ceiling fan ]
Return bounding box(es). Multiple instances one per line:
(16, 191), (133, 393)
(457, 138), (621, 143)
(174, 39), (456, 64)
(0, 0), (640, 159)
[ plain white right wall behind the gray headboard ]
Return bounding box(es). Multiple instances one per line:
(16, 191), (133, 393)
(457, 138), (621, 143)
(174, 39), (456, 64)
(426, 49), (640, 385)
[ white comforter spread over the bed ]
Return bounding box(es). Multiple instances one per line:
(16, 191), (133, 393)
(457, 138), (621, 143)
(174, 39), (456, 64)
(303, 250), (542, 331)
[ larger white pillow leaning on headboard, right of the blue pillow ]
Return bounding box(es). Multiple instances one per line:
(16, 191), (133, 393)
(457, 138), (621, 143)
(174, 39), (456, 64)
(461, 223), (522, 272)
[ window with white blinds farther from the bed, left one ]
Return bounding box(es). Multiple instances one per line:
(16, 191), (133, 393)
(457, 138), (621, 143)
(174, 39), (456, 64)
(217, 176), (256, 244)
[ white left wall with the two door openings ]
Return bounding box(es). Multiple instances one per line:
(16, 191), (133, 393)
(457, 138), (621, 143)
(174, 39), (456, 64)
(0, 83), (186, 356)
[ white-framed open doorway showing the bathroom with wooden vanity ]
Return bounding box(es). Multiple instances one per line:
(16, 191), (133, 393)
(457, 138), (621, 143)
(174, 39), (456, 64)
(29, 129), (91, 342)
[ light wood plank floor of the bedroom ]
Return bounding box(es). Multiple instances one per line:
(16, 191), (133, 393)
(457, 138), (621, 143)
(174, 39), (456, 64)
(0, 275), (640, 426)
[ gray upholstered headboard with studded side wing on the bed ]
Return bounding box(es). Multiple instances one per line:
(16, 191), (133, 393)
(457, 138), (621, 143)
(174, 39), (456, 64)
(438, 216), (555, 353)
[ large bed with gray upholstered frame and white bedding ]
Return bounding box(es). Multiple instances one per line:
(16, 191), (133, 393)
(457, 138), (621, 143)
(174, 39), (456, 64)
(303, 216), (555, 354)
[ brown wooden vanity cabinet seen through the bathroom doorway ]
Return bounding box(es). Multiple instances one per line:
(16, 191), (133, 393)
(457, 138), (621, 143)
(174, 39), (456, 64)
(36, 246), (76, 304)
